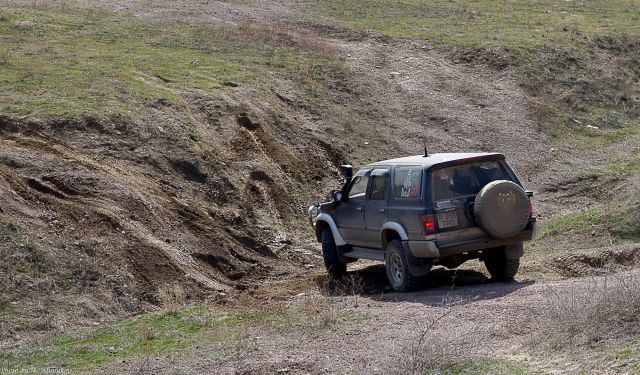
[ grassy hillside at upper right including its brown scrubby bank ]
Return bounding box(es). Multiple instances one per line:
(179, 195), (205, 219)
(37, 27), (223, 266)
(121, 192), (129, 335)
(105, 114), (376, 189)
(303, 0), (640, 141)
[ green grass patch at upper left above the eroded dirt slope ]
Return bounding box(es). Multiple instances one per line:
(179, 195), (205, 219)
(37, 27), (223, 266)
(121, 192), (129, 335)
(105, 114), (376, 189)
(0, 5), (336, 117)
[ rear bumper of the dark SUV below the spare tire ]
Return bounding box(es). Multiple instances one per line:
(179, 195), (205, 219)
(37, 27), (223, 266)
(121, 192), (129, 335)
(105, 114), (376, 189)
(407, 223), (536, 258)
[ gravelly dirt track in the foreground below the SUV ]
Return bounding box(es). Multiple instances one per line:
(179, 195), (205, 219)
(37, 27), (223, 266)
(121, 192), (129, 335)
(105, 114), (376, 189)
(94, 267), (640, 374)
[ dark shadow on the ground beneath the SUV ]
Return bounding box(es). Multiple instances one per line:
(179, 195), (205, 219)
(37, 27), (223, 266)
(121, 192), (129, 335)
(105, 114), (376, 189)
(316, 265), (535, 306)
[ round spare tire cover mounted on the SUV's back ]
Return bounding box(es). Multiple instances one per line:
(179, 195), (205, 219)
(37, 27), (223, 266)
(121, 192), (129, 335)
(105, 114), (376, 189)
(473, 180), (529, 238)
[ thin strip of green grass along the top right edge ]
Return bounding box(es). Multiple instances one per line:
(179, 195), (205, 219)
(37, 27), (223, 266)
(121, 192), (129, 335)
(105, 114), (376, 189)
(303, 0), (640, 51)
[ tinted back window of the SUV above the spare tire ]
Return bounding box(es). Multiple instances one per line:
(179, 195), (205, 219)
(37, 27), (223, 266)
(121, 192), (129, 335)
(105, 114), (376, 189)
(432, 161), (511, 200)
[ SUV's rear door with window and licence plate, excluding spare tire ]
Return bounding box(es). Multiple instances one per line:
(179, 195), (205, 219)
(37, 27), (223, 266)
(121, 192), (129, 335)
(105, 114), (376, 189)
(431, 160), (514, 245)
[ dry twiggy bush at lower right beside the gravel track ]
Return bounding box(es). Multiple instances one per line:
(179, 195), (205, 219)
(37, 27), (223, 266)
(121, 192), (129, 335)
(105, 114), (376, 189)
(530, 273), (640, 349)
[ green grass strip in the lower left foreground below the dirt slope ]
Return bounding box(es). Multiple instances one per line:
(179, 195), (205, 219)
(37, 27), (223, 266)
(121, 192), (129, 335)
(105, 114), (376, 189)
(0, 304), (368, 370)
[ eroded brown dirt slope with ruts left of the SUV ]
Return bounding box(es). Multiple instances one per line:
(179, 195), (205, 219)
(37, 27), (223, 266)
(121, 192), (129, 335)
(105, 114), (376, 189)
(0, 87), (348, 334)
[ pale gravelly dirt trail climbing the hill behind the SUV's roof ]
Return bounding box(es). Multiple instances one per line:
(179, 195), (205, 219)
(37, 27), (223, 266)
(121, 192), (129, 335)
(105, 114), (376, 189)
(340, 38), (550, 176)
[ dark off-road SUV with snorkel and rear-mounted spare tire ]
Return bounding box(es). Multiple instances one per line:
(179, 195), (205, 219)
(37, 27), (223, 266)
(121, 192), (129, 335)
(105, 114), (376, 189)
(308, 153), (536, 291)
